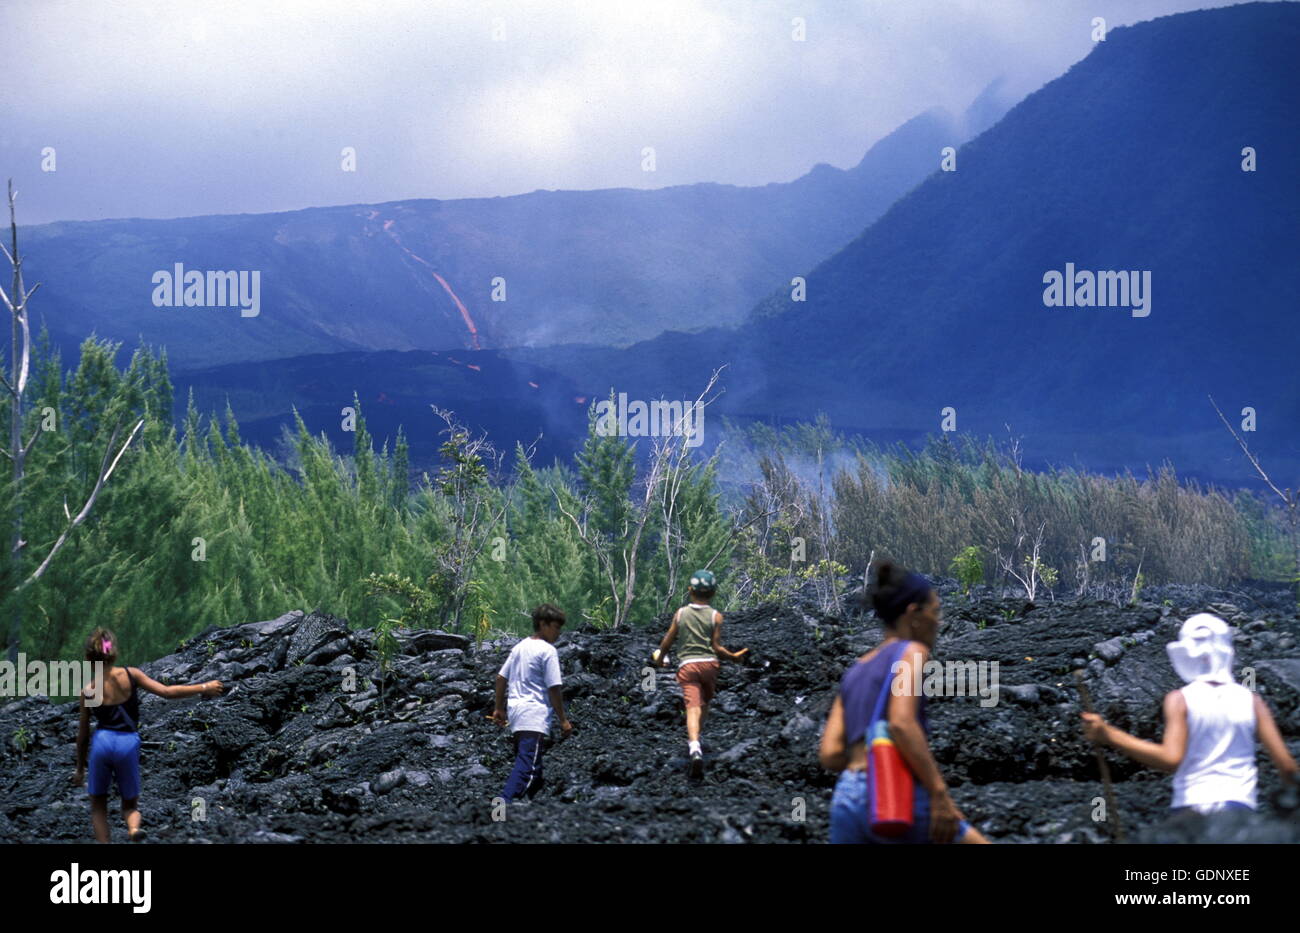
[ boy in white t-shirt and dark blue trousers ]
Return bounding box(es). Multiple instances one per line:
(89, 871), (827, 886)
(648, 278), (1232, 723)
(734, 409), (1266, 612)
(489, 603), (573, 803)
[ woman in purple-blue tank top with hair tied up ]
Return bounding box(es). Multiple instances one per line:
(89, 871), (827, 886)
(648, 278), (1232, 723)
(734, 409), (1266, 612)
(819, 561), (988, 845)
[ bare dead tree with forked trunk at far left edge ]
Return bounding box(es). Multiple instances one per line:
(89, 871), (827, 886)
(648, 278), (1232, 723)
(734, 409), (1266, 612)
(0, 178), (144, 661)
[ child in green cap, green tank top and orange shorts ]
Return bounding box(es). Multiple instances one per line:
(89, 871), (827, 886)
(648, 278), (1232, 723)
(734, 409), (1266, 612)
(653, 570), (749, 777)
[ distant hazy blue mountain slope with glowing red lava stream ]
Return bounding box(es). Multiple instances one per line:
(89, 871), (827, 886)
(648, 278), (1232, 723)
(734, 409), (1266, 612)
(21, 88), (1005, 369)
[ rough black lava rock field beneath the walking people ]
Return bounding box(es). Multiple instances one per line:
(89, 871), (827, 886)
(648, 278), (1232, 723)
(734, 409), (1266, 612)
(0, 585), (1300, 843)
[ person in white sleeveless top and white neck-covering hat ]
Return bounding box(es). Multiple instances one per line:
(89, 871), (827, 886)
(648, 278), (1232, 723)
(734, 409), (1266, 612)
(1083, 612), (1297, 813)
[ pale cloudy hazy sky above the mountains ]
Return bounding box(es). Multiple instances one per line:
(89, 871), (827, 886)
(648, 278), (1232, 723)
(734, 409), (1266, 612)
(0, 0), (1268, 224)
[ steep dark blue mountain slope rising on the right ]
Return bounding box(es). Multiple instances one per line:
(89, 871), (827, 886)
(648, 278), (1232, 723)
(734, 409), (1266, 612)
(506, 3), (1300, 481)
